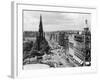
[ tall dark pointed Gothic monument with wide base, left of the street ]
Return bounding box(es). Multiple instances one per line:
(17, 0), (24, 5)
(30, 15), (50, 55)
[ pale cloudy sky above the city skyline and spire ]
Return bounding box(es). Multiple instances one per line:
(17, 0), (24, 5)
(23, 11), (91, 31)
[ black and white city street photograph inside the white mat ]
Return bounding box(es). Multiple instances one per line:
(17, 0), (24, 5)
(22, 10), (91, 70)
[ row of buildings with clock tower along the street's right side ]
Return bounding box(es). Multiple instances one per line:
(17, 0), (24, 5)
(69, 27), (91, 66)
